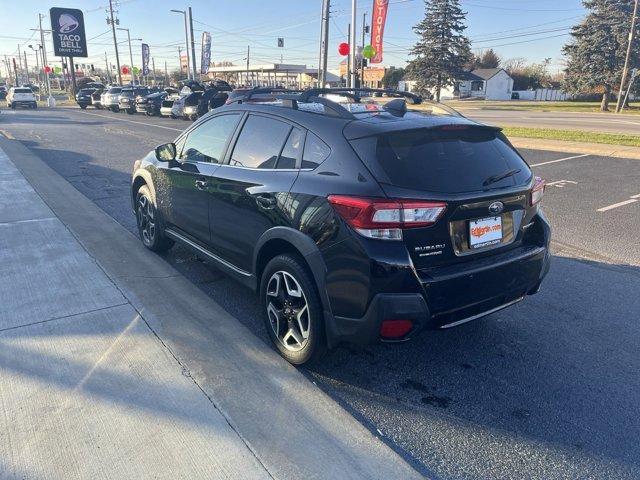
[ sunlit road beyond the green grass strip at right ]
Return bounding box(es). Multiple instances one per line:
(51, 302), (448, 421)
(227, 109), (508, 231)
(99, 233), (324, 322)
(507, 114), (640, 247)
(456, 106), (640, 135)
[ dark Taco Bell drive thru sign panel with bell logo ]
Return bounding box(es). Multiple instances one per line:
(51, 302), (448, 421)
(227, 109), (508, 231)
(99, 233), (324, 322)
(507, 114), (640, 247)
(49, 7), (88, 57)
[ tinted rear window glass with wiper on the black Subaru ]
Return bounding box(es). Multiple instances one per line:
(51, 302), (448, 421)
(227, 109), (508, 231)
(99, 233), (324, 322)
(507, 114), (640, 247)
(352, 128), (531, 193)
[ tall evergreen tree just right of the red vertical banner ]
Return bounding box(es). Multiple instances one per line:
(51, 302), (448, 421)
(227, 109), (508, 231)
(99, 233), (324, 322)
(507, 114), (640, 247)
(407, 0), (471, 101)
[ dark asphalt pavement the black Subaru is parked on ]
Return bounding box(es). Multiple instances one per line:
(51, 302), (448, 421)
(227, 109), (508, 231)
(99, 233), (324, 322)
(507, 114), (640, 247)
(0, 109), (640, 479)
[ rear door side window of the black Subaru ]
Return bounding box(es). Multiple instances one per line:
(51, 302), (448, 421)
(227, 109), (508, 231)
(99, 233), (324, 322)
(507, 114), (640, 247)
(229, 115), (291, 168)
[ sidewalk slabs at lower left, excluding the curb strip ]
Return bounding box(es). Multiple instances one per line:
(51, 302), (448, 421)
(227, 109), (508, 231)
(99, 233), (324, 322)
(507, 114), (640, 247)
(0, 150), (270, 479)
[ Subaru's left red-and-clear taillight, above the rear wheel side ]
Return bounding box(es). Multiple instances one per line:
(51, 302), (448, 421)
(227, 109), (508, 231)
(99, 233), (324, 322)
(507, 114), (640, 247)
(328, 195), (447, 240)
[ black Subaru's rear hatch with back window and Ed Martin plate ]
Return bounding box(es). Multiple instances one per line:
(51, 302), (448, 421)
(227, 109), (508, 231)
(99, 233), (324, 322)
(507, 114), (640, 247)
(351, 124), (536, 269)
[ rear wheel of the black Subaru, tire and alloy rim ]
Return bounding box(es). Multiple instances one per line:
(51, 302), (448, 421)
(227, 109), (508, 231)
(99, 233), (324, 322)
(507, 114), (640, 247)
(260, 254), (326, 365)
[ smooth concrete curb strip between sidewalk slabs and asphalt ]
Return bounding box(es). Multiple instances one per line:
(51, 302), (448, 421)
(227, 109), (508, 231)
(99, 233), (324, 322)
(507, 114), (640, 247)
(0, 137), (430, 479)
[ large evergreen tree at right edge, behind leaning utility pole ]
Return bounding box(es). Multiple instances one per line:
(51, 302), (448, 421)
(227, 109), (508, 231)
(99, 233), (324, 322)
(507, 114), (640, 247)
(563, 0), (640, 111)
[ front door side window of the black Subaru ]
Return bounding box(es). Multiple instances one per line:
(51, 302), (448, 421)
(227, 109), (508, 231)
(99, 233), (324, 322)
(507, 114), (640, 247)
(180, 113), (241, 163)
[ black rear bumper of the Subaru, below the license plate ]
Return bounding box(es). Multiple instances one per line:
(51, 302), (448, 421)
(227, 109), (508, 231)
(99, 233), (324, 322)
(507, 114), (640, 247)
(325, 246), (550, 344)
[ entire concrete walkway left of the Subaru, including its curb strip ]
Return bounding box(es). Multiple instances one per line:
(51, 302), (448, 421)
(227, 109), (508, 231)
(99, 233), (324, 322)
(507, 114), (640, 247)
(0, 138), (428, 479)
